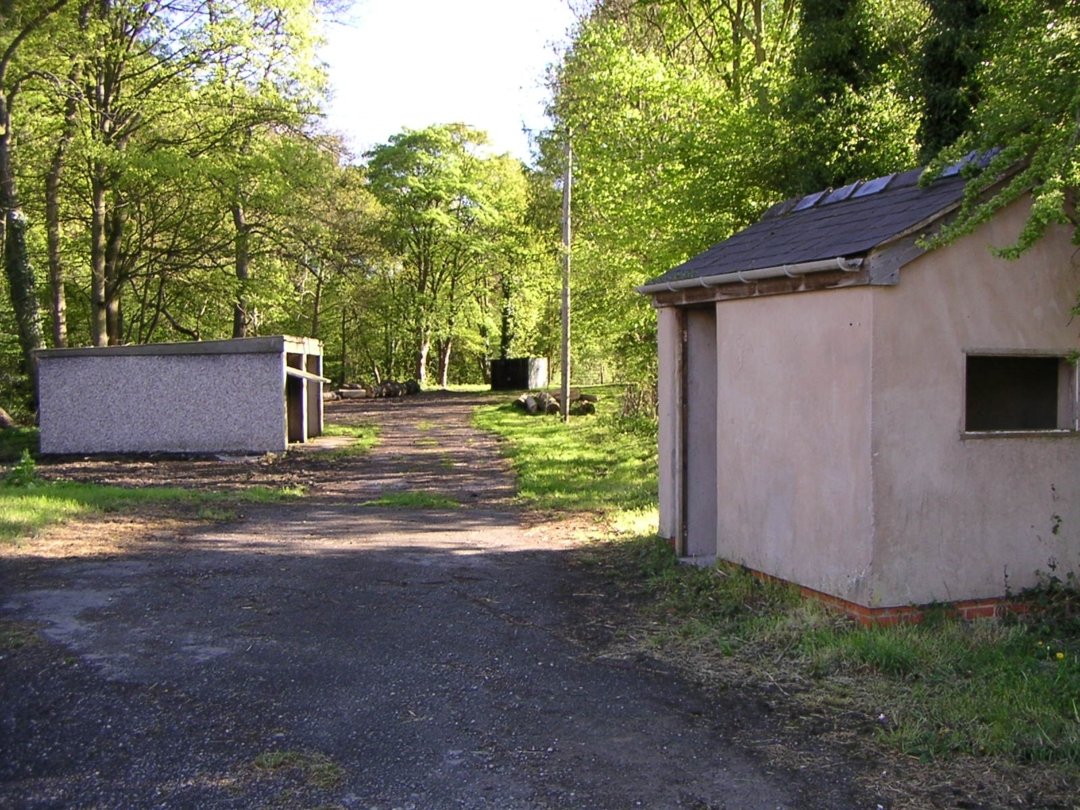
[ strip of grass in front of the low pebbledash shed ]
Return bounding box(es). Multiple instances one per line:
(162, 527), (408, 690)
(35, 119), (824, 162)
(0, 481), (302, 542)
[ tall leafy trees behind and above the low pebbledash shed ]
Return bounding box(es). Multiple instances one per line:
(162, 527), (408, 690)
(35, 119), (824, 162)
(0, 0), (401, 406)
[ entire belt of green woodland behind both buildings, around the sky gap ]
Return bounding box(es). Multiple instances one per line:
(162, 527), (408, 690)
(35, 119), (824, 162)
(0, 0), (1080, 415)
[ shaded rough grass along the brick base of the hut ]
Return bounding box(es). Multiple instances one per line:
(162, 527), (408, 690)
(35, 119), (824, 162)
(582, 537), (1080, 768)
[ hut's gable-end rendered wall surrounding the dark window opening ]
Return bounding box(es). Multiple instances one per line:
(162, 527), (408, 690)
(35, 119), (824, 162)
(870, 204), (1080, 605)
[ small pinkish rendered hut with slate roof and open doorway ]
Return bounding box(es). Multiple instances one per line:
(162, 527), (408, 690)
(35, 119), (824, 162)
(639, 165), (1080, 618)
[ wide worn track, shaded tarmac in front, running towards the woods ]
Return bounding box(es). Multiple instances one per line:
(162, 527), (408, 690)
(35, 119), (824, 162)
(0, 395), (877, 808)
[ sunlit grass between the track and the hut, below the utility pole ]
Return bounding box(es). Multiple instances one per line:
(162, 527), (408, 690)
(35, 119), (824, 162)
(474, 387), (657, 515)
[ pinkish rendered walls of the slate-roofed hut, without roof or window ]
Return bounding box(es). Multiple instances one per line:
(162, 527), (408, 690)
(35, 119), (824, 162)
(659, 202), (1080, 612)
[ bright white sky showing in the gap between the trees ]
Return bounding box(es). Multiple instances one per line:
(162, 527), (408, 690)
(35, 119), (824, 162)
(321, 0), (573, 162)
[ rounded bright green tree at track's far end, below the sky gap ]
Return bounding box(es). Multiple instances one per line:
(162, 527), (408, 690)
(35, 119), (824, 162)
(367, 124), (544, 386)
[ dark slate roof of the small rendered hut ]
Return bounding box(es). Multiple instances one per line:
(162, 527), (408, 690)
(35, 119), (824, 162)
(646, 162), (974, 286)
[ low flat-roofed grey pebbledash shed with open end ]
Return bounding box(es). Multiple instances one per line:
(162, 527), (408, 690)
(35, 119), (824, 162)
(37, 335), (324, 455)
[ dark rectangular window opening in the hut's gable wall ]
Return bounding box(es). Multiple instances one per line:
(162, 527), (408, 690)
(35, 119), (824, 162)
(966, 354), (1062, 431)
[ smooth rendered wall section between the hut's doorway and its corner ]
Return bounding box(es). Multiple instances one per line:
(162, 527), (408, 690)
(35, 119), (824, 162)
(716, 287), (873, 602)
